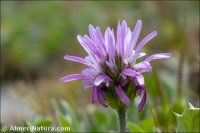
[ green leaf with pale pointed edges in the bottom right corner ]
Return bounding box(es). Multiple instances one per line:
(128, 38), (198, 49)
(174, 103), (200, 132)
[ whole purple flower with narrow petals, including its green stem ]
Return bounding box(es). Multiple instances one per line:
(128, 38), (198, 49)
(60, 20), (171, 132)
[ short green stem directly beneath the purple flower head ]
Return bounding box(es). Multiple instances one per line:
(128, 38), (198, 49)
(117, 107), (127, 133)
